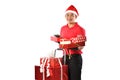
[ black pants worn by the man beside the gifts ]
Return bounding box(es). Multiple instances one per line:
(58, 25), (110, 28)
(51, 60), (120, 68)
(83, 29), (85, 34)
(63, 54), (82, 80)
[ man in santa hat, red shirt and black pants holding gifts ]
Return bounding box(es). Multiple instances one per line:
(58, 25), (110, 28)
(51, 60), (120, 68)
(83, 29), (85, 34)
(60, 5), (85, 80)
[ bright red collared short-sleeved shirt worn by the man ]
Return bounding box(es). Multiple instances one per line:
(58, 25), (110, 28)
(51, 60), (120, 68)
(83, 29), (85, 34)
(60, 23), (85, 54)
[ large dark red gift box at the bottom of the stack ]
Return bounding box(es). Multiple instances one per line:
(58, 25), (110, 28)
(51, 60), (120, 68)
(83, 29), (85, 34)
(35, 65), (68, 80)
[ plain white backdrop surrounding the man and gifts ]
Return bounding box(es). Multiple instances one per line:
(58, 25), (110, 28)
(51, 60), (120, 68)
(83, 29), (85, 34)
(0, 0), (120, 80)
